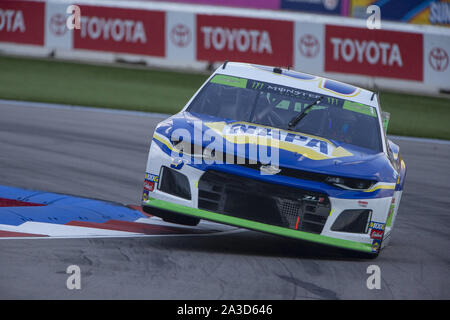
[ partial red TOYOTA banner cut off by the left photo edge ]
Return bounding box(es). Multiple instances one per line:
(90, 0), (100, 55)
(0, 0), (45, 45)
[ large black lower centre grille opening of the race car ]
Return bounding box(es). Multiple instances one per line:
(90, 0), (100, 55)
(198, 171), (330, 234)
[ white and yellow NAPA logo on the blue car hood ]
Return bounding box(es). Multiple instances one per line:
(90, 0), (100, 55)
(205, 121), (353, 160)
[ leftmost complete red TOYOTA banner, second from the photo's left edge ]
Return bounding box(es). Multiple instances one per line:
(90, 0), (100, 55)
(73, 5), (166, 57)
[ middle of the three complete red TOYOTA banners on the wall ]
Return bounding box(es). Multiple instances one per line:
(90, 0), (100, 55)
(196, 15), (293, 66)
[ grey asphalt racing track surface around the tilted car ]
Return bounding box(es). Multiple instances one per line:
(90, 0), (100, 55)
(0, 102), (450, 299)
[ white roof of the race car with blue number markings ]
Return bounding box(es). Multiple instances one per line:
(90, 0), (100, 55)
(215, 62), (378, 109)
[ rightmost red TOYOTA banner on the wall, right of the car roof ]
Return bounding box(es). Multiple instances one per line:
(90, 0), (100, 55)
(325, 25), (423, 81)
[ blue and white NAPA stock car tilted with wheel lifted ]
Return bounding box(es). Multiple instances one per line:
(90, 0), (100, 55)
(142, 62), (406, 257)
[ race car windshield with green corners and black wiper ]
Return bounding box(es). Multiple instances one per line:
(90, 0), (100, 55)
(187, 74), (382, 152)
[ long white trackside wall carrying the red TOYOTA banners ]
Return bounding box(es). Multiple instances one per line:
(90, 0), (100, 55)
(0, 0), (450, 94)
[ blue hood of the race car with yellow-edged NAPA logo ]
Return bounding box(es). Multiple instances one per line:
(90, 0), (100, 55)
(155, 112), (395, 182)
